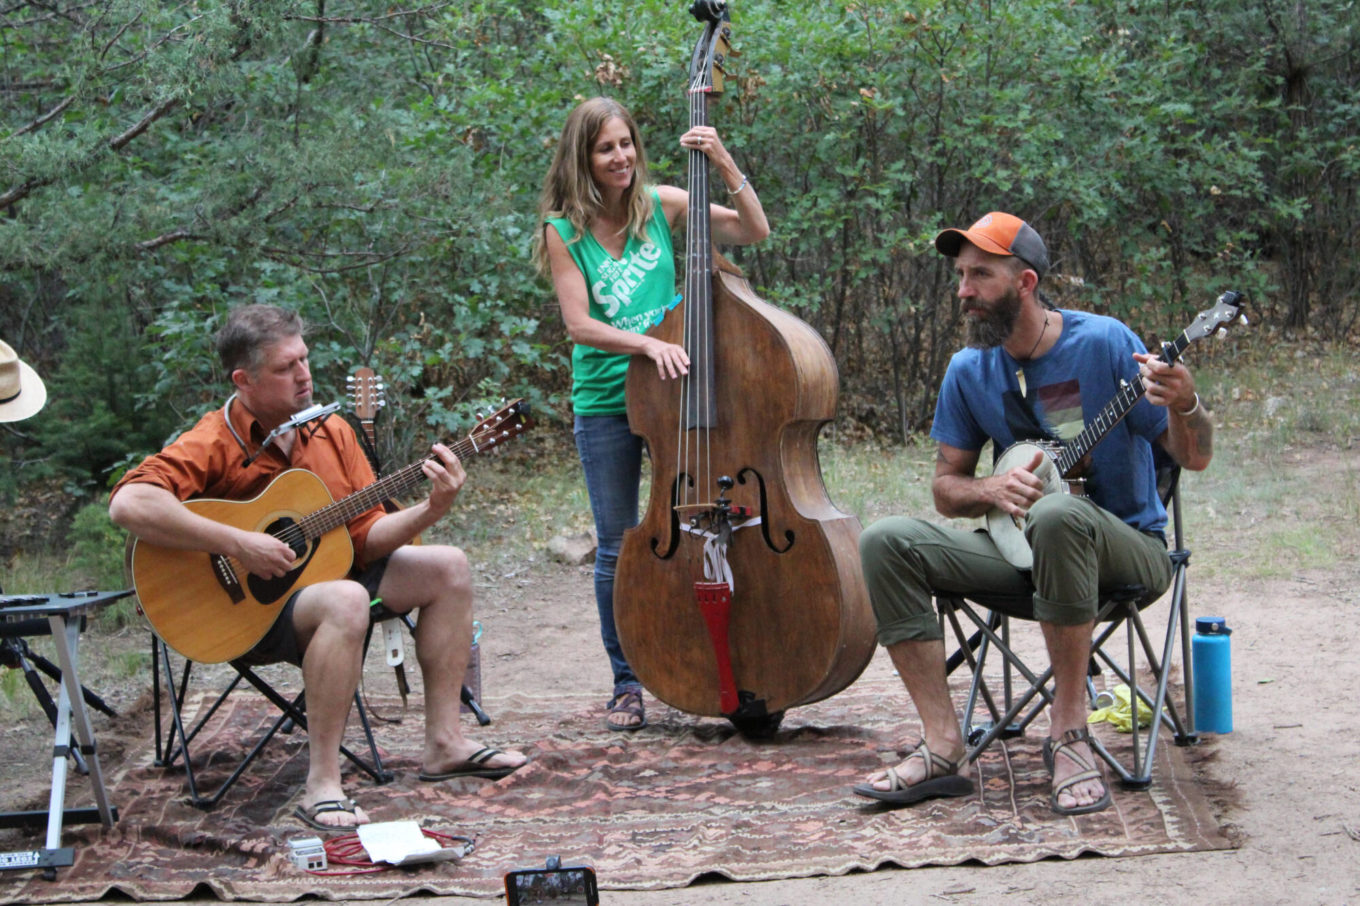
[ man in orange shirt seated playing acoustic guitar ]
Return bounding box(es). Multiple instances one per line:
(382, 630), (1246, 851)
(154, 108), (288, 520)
(109, 305), (525, 830)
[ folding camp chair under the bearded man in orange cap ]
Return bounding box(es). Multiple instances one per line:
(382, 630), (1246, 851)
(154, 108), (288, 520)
(936, 450), (1197, 789)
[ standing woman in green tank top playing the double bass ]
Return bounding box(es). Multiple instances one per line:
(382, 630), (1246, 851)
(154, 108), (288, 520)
(534, 98), (770, 731)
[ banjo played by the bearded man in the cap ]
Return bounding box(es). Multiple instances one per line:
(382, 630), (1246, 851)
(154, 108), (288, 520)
(985, 290), (1246, 570)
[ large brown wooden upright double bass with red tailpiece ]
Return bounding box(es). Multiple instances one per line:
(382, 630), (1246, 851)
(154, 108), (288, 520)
(615, 0), (873, 736)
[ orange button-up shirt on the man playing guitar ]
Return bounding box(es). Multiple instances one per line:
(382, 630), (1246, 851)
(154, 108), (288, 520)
(110, 400), (384, 565)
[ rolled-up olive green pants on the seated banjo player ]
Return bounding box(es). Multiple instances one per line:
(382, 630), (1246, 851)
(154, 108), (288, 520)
(860, 494), (1171, 646)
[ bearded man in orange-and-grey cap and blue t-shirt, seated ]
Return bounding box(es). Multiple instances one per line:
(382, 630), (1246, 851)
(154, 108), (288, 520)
(854, 212), (1213, 815)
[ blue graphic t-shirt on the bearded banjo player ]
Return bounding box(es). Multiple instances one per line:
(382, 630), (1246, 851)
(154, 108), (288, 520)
(930, 310), (1167, 532)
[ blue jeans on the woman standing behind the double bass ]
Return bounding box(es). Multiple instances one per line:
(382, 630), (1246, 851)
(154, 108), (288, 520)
(574, 415), (642, 695)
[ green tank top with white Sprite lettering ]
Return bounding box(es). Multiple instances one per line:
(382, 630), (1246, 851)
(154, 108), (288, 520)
(548, 188), (676, 415)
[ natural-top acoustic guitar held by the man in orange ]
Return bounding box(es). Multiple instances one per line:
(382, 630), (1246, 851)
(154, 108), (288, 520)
(129, 400), (533, 664)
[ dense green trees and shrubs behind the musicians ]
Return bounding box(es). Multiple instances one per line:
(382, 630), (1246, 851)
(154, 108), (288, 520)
(0, 0), (1360, 544)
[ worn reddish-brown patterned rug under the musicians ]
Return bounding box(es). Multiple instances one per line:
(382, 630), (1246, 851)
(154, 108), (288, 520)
(0, 680), (1234, 903)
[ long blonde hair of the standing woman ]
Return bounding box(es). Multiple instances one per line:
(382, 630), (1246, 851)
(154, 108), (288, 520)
(533, 98), (651, 276)
